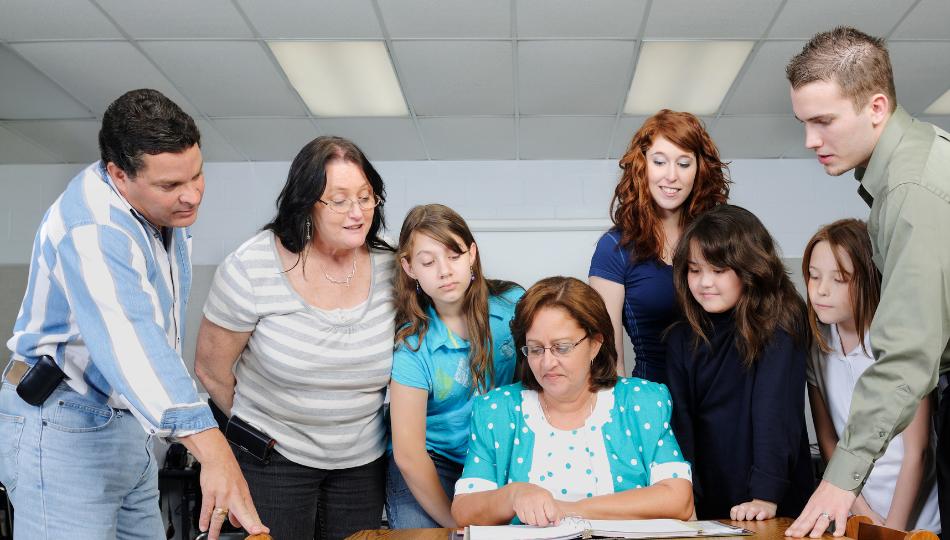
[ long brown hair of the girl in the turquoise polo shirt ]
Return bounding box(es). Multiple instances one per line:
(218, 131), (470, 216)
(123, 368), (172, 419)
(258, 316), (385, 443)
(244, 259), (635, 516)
(395, 204), (518, 392)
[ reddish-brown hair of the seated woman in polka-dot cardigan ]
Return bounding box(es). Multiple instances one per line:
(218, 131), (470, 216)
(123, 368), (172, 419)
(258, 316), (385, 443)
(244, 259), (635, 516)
(511, 276), (617, 392)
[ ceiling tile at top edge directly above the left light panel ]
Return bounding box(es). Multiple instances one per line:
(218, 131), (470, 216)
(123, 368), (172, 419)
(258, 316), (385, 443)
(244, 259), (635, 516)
(237, 0), (383, 39)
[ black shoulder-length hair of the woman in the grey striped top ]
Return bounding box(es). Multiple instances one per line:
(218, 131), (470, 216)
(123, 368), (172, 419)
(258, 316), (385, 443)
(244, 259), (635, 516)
(262, 136), (394, 263)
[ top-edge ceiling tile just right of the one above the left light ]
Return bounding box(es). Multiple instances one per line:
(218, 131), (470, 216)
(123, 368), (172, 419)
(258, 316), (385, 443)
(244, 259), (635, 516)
(379, 0), (511, 39)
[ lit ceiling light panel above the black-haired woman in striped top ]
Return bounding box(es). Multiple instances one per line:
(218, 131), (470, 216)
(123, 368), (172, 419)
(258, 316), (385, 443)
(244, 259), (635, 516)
(267, 41), (409, 116)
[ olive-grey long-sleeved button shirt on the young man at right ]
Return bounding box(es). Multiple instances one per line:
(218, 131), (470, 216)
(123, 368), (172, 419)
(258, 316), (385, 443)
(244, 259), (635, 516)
(824, 106), (950, 493)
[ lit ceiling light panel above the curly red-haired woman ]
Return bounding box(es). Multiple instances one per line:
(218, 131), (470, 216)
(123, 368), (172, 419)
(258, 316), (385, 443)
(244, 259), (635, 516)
(623, 41), (753, 115)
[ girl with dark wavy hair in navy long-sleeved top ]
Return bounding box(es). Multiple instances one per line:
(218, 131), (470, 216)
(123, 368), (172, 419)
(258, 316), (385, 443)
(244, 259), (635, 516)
(667, 204), (814, 520)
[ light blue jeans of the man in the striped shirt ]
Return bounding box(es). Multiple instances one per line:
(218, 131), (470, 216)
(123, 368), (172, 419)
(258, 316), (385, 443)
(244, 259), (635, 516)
(0, 380), (165, 540)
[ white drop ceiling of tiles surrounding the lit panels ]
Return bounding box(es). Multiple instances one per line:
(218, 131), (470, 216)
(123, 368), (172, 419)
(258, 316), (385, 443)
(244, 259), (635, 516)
(0, 0), (950, 160)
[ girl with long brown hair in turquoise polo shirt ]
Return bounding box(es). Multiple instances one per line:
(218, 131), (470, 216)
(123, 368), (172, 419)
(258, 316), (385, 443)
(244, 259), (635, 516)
(386, 204), (524, 529)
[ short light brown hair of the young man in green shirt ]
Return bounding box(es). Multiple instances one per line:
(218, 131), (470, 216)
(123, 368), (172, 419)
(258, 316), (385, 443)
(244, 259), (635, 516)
(785, 26), (897, 112)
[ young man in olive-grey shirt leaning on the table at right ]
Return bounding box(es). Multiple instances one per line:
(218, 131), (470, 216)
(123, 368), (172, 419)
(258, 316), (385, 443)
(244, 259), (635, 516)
(785, 27), (950, 537)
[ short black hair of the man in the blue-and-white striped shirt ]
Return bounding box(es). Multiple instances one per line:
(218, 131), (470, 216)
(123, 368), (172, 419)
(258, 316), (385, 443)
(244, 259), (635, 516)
(99, 88), (201, 178)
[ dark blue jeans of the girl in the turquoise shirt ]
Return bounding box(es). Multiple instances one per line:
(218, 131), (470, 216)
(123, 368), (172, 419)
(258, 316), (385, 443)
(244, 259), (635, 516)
(386, 452), (462, 529)
